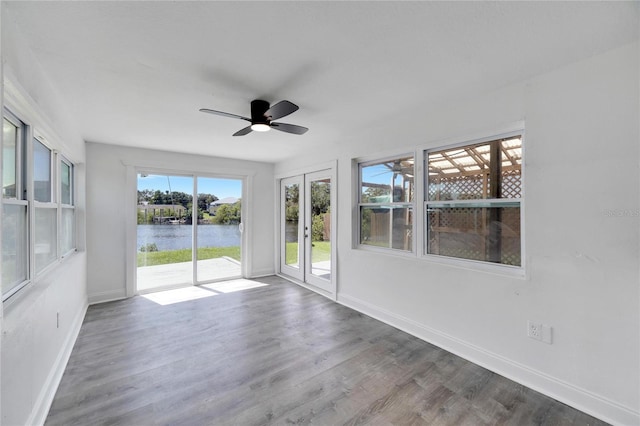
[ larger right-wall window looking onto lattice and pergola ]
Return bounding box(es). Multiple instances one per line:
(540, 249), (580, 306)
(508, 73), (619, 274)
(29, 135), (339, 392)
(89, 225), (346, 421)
(425, 134), (522, 267)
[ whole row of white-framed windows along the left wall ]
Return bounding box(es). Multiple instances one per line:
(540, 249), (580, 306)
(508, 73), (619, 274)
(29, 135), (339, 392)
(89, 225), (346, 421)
(2, 110), (75, 301)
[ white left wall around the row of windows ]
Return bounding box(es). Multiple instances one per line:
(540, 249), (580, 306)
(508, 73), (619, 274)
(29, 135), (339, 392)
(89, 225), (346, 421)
(0, 8), (87, 425)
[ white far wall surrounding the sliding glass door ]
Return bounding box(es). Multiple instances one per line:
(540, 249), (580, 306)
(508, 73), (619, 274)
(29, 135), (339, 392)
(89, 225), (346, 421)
(87, 143), (274, 303)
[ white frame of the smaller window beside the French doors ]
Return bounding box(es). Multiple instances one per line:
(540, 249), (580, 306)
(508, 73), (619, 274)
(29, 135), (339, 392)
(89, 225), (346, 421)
(353, 151), (419, 257)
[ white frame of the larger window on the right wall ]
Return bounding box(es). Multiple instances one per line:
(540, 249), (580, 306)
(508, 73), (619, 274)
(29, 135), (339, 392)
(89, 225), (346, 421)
(421, 130), (526, 277)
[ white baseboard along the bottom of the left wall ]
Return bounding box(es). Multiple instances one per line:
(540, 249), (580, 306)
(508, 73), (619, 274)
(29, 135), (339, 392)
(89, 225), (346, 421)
(27, 303), (89, 425)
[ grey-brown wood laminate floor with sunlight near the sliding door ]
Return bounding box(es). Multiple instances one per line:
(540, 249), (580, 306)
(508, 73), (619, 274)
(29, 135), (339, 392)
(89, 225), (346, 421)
(46, 277), (605, 426)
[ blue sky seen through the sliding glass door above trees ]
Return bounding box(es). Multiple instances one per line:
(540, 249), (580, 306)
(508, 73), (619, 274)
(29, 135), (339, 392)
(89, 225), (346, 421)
(138, 175), (242, 198)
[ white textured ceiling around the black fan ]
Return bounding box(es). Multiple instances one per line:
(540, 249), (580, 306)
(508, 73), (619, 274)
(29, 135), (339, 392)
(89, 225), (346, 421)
(2, 1), (638, 162)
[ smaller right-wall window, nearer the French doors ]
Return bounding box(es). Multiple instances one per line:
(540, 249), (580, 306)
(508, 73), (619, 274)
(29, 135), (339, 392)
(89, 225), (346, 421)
(358, 155), (415, 252)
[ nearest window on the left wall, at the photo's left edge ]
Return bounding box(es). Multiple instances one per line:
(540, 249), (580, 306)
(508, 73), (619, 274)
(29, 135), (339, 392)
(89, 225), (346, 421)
(2, 114), (29, 300)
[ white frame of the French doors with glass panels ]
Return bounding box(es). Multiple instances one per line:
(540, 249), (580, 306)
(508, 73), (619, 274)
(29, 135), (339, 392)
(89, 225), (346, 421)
(274, 160), (338, 301)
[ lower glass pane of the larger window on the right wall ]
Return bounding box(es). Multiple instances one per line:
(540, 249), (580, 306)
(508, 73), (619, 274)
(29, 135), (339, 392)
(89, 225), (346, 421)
(427, 206), (521, 266)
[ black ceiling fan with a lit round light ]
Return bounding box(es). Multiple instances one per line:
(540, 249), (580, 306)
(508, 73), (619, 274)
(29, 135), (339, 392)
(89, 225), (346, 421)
(200, 99), (309, 136)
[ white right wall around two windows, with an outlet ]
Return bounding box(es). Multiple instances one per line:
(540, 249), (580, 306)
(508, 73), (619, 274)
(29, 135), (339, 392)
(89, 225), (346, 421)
(276, 43), (640, 424)
